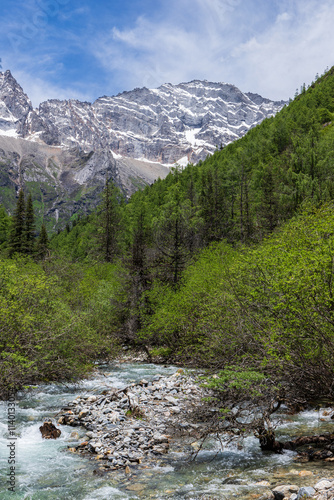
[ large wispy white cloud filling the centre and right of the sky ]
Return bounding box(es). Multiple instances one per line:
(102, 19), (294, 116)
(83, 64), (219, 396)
(92, 0), (334, 99)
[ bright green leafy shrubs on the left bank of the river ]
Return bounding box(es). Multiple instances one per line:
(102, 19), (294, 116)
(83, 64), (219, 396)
(0, 258), (112, 397)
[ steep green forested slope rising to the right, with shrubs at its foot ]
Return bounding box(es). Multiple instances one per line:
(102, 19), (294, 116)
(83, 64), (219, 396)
(0, 68), (334, 406)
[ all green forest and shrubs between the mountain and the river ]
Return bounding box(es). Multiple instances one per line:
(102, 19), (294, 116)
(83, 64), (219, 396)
(0, 68), (334, 434)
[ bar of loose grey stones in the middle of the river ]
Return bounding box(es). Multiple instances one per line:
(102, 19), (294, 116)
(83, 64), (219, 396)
(59, 370), (204, 469)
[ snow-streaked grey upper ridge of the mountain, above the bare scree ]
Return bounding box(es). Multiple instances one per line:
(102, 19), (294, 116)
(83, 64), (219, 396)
(0, 71), (285, 165)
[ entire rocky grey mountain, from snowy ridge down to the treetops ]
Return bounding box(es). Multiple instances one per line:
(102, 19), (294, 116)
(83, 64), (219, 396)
(0, 71), (285, 230)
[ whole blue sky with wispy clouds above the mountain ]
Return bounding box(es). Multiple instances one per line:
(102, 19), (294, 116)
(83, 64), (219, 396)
(0, 0), (334, 106)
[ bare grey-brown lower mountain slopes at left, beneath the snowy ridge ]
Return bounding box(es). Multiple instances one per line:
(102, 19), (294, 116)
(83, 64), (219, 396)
(0, 135), (169, 230)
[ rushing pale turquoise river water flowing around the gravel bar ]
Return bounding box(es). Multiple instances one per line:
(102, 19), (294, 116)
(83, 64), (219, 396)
(0, 364), (333, 500)
